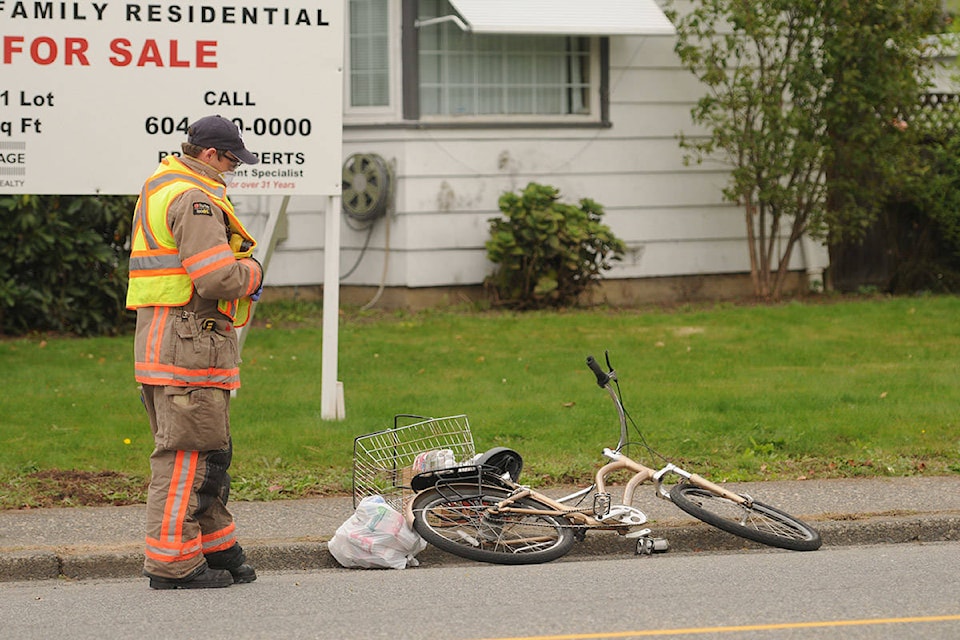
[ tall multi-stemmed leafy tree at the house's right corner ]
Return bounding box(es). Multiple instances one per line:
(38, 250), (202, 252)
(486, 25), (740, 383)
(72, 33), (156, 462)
(668, 0), (939, 299)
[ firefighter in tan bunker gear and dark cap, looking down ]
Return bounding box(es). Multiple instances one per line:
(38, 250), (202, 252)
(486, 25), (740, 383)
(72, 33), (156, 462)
(127, 116), (263, 589)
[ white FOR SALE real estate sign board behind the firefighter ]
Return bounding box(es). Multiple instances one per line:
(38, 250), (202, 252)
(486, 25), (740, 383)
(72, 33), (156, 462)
(0, 0), (345, 195)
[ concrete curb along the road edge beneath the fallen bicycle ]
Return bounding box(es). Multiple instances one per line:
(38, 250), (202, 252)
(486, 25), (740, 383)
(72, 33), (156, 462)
(0, 514), (960, 582)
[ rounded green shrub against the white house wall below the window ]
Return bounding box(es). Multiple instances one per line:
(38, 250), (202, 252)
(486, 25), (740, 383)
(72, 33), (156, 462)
(486, 182), (625, 309)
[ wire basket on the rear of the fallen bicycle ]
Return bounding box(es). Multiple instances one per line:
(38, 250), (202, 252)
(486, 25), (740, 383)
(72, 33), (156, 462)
(353, 414), (476, 511)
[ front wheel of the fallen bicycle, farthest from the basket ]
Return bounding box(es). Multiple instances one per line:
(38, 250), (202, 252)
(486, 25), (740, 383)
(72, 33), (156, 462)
(670, 482), (821, 551)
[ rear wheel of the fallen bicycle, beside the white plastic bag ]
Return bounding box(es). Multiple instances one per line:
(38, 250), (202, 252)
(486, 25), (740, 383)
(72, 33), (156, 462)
(413, 484), (574, 564)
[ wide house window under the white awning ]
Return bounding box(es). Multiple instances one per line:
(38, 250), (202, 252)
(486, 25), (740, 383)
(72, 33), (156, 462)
(417, 0), (596, 118)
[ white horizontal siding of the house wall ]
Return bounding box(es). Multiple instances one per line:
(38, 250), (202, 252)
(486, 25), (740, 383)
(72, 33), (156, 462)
(229, 20), (828, 298)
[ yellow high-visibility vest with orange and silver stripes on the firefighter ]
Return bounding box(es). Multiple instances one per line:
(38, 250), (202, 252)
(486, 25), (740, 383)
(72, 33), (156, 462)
(127, 156), (256, 327)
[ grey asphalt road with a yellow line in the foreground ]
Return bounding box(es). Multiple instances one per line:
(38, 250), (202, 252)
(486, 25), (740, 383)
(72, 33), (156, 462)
(0, 542), (960, 640)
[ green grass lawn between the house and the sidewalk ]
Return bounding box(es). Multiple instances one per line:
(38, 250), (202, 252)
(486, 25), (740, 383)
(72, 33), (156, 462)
(0, 297), (960, 508)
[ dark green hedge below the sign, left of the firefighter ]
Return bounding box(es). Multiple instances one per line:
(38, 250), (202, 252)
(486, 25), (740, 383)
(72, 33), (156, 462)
(0, 195), (136, 335)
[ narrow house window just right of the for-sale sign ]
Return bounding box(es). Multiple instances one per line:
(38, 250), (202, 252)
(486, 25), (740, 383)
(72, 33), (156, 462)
(349, 0), (390, 107)
